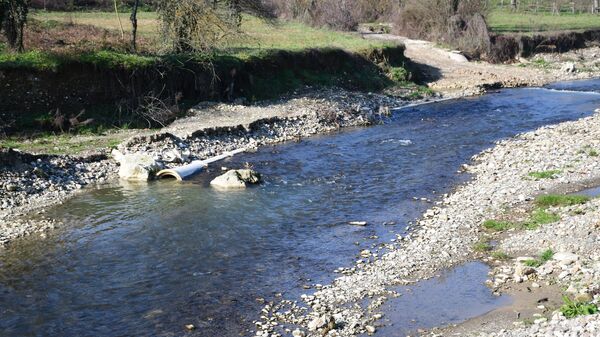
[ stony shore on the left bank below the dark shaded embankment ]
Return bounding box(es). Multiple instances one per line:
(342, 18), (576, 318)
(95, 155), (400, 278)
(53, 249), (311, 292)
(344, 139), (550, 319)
(0, 88), (408, 245)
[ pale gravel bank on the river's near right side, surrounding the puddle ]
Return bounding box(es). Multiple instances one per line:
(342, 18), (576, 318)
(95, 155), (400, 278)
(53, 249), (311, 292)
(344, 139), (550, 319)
(251, 110), (600, 336)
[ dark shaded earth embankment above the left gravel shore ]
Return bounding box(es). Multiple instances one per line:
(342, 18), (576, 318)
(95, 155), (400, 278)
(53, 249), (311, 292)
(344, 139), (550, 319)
(0, 45), (406, 132)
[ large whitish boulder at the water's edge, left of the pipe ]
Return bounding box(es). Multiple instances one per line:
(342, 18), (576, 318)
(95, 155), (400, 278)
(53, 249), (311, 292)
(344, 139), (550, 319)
(113, 150), (162, 181)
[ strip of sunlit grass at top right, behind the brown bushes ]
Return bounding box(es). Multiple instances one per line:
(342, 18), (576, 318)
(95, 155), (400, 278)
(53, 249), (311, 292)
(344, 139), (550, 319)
(488, 9), (600, 33)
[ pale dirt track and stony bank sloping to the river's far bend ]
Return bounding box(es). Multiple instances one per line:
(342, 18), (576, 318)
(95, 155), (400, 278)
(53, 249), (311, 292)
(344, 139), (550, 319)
(363, 34), (599, 97)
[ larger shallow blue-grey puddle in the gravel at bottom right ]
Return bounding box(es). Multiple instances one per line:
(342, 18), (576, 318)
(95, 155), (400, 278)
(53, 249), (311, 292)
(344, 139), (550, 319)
(378, 262), (512, 337)
